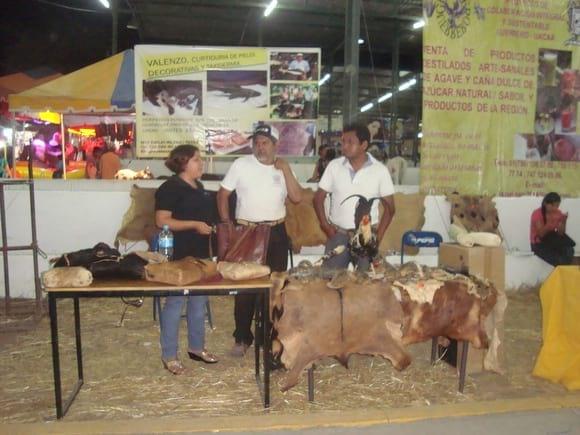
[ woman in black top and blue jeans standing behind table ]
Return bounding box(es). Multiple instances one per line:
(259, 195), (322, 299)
(155, 145), (218, 375)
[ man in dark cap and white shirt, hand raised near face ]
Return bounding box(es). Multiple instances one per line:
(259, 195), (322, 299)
(217, 124), (302, 356)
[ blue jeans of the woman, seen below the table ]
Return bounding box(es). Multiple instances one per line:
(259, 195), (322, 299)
(159, 296), (207, 361)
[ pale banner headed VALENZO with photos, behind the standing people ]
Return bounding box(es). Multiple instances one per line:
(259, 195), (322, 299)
(135, 45), (320, 158)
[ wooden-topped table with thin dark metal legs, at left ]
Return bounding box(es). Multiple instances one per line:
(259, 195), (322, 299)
(44, 278), (271, 419)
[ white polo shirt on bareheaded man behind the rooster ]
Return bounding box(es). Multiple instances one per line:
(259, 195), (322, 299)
(318, 153), (395, 230)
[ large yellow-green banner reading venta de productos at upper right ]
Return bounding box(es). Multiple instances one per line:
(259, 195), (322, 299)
(421, 0), (580, 196)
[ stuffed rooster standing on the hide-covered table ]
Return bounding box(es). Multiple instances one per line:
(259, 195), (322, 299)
(342, 195), (380, 268)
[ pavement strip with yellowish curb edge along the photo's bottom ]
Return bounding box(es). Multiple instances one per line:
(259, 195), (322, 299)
(0, 393), (580, 435)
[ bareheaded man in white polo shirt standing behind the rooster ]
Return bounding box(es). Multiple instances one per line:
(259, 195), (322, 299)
(314, 123), (395, 270)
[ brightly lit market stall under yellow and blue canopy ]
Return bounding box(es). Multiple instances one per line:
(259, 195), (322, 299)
(9, 50), (135, 179)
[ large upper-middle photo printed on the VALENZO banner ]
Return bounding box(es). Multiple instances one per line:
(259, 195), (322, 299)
(206, 70), (268, 111)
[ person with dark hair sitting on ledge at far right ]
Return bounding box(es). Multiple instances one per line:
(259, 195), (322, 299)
(530, 192), (576, 266)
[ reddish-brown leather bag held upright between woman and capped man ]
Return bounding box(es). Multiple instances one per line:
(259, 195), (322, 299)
(217, 223), (271, 264)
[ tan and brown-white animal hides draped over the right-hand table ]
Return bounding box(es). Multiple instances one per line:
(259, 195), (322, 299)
(271, 264), (498, 390)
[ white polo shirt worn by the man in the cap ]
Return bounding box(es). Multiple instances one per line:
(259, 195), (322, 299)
(221, 154), (288, 222)
